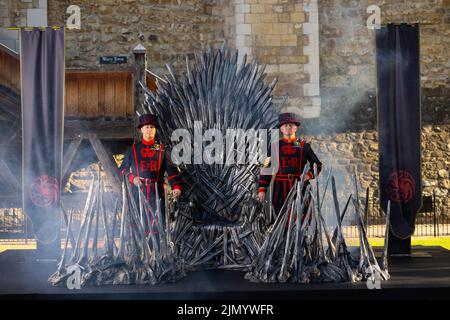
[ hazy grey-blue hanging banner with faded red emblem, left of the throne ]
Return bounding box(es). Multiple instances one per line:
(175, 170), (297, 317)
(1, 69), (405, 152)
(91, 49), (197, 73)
(20, 28), (64, 243)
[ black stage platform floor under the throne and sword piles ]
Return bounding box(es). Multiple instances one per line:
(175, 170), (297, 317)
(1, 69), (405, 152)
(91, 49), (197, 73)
(0, 246), (450, 300)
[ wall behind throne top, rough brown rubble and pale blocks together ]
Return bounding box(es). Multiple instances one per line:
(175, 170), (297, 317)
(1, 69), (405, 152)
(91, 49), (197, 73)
(48, 0), (320, 117)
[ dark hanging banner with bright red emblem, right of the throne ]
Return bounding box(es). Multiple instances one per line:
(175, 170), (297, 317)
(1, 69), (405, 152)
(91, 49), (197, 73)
(376, 24), (422, 239)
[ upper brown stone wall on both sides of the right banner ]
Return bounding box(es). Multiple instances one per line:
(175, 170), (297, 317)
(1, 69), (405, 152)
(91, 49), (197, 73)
(319, 0), (450, 131)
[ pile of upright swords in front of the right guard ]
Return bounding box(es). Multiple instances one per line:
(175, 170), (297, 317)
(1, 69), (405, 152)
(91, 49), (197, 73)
(245, 166), (390, 283)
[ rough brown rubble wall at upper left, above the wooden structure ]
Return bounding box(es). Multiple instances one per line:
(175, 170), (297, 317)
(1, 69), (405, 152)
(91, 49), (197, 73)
(48, 0), (224, 73)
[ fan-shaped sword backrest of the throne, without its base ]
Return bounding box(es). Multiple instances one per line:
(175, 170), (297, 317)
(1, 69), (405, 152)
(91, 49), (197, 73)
(142, 45), (277, 224)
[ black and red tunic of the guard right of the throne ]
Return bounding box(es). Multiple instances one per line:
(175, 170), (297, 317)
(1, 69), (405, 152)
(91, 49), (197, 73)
(259, 138), (322, 214)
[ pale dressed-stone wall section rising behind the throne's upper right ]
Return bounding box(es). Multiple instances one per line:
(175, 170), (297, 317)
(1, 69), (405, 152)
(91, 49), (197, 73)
(222, 0), (320, 117)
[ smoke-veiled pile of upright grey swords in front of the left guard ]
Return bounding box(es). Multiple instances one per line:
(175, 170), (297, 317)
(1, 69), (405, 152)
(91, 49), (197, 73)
(48, 175), (184, 286)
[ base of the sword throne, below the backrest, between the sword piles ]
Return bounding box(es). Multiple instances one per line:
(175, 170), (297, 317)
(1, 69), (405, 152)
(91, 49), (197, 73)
(172, 200), (269, 271)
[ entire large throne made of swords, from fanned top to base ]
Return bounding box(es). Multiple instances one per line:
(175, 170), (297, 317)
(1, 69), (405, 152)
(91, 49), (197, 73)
(138, 45), (277, 269)
